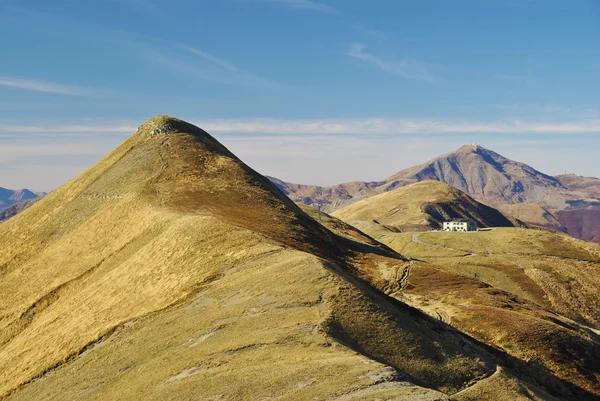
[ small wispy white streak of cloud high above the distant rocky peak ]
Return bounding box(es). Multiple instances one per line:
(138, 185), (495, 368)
(344, 43), (436, 82)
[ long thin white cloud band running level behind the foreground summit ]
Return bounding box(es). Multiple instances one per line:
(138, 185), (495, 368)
(5, 118), (600, 138)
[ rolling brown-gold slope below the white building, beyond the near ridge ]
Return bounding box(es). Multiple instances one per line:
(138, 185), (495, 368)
(350, 222), (600, 394)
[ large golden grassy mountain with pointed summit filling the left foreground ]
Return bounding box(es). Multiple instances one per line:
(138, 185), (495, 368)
(0, 116), (600, 401)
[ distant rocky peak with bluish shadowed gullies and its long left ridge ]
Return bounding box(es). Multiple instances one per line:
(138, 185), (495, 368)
(276, 145), (568, 211)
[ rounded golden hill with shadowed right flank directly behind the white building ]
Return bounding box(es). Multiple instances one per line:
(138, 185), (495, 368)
(333, 180), (518, 230)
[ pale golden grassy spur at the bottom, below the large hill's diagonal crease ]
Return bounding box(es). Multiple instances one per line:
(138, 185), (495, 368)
(11, 241), (440, 400)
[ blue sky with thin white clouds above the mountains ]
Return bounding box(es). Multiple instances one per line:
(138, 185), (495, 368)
(0, 0), (600, 191)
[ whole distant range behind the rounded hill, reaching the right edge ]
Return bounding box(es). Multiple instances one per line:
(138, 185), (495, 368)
(271, 144), (600, 242)
